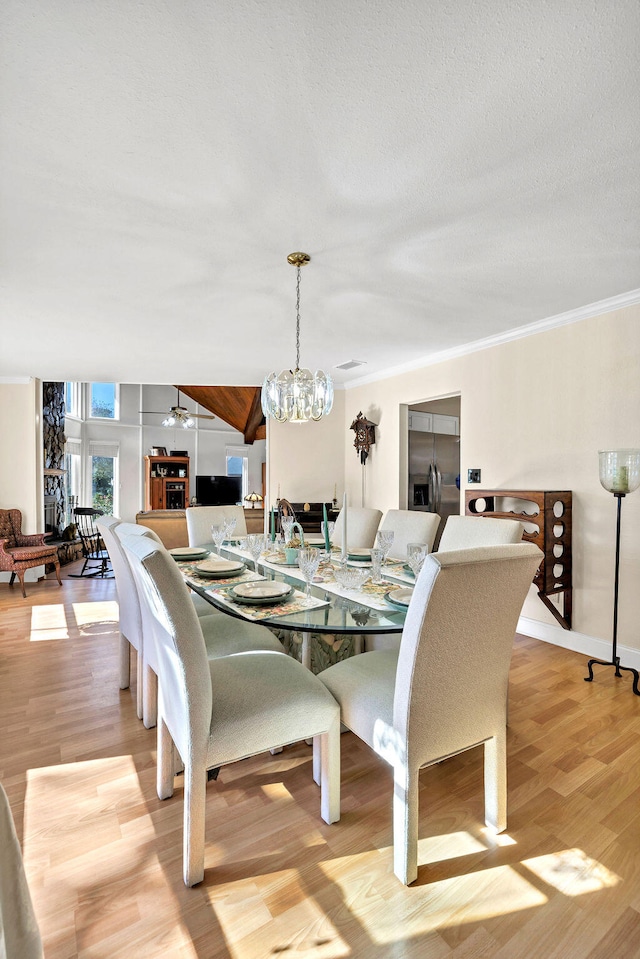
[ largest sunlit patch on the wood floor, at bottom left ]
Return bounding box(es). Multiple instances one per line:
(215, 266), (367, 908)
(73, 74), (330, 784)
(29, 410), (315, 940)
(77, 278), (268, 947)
(23, 756), (197, 957)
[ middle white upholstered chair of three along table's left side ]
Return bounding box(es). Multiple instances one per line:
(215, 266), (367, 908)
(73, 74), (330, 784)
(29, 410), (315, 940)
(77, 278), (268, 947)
(115, 523), (285, 729)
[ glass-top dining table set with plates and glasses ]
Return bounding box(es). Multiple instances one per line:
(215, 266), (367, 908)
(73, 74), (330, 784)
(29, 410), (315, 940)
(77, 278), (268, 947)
(179, 546), (407, 672)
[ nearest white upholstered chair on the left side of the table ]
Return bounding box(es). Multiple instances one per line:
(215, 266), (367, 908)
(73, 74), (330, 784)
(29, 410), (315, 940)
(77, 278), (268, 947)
(123, 537), (340, 886)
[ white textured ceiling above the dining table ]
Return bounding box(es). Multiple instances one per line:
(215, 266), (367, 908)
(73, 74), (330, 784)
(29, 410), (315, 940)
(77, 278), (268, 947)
(0, 0), (640, 385)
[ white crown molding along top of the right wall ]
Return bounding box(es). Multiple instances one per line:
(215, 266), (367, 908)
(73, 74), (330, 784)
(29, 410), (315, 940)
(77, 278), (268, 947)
(344, 289), (640, 390)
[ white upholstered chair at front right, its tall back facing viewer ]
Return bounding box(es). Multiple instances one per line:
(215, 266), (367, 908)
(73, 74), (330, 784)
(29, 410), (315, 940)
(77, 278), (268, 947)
(318, 543), (543, 884)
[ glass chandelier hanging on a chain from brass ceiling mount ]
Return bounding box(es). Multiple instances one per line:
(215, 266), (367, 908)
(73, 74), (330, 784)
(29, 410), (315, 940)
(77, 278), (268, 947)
(262, 253), (333, 423)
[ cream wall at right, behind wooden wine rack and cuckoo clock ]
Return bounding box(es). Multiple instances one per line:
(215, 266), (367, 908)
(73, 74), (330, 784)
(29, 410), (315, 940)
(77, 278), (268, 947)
(344, 306), (640, 650)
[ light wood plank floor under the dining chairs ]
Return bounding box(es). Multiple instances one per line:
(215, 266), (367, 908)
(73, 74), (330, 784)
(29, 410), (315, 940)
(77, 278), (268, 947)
(0, 568), (640, 959)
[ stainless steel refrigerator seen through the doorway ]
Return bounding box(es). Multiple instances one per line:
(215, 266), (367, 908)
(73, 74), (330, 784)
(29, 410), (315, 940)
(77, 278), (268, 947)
(409, 429), (460, 547)
